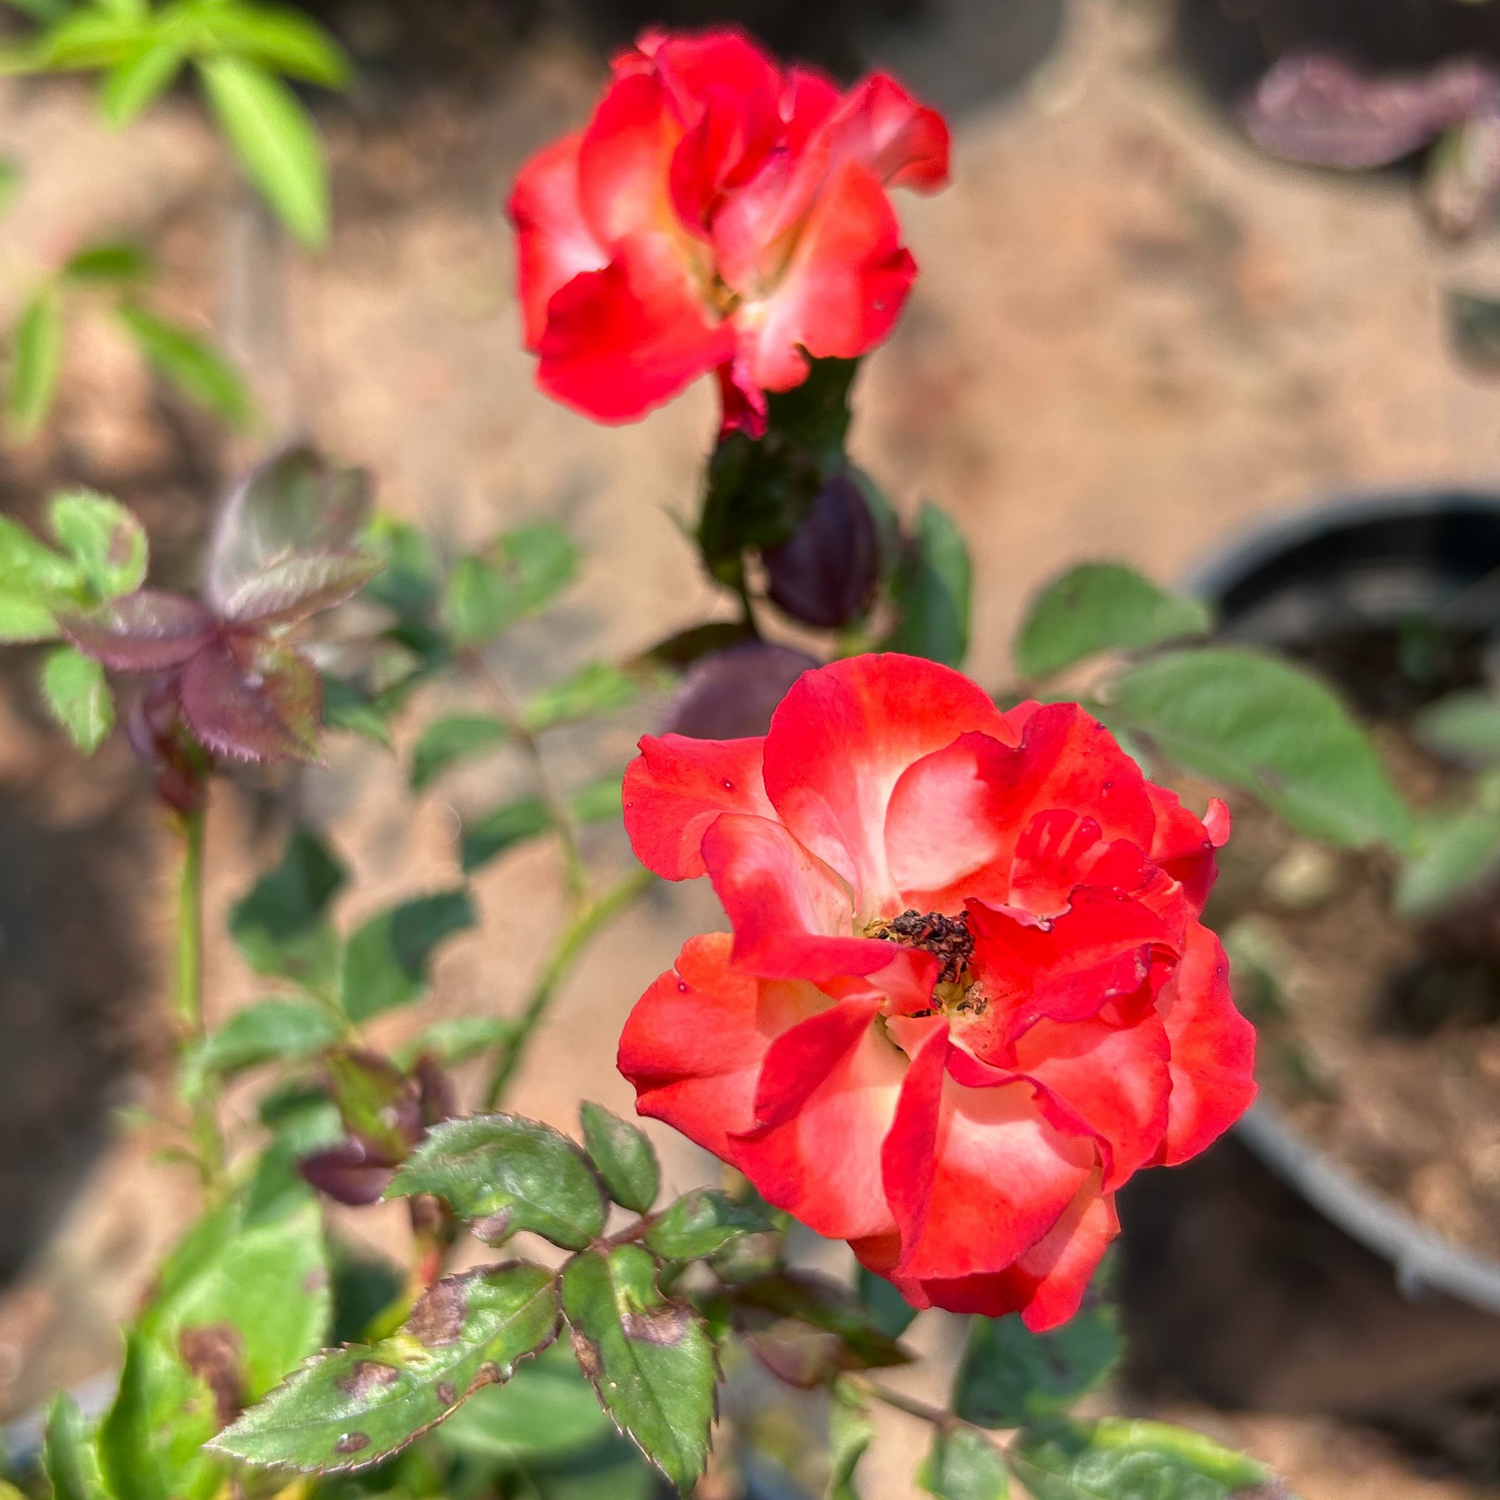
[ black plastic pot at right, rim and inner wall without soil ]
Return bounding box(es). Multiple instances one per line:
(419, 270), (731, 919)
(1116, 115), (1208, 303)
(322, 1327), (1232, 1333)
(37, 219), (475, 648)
(1187, 489), (1500, 1314)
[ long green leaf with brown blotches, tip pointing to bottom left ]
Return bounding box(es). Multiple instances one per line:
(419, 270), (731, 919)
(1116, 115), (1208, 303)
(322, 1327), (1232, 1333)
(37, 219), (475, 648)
(213, 1262), (558, 1473)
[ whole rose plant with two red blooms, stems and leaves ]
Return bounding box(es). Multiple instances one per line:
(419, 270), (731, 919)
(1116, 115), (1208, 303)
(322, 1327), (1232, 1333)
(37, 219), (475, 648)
(0, 17), (1440, 1500)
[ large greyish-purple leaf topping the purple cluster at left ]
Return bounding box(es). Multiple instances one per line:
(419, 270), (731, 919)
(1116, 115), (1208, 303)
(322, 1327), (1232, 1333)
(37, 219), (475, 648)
(204, 447), (372, 612)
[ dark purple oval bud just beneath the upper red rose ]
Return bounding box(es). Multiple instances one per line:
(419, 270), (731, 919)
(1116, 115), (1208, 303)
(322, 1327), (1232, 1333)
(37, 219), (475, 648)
(764, 473), (881, 630)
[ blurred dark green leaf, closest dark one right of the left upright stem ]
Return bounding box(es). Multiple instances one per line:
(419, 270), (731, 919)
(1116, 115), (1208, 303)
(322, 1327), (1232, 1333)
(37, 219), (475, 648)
(230, 828), (347, 980)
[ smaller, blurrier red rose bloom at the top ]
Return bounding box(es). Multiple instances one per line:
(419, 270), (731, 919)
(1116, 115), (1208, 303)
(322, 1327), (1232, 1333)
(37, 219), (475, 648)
(510, 32), (948, 432)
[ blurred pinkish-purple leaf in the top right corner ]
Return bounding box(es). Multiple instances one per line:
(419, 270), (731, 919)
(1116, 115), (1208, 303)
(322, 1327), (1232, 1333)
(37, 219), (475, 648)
(1244, 53), (1500, 170)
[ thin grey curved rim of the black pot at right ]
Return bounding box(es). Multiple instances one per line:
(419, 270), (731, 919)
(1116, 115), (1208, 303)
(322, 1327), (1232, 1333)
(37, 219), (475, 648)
(1181, 480), (1500, 1316)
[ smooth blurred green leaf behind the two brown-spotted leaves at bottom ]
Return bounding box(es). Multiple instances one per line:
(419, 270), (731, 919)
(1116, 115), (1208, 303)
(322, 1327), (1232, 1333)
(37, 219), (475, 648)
(440, 1344), (614, 1467)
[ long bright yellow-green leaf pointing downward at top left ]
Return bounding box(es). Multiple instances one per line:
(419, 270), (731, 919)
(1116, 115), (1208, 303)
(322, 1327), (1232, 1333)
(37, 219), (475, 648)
(198, 57), (329, 251)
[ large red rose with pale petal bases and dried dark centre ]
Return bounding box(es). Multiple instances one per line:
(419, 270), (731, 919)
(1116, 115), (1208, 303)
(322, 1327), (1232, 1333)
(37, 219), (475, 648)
(620, 656), (1254, 1329)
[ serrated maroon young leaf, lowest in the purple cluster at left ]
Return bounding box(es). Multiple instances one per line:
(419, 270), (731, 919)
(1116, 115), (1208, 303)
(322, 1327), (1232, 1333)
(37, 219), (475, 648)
(182, 632), (323, 765)
